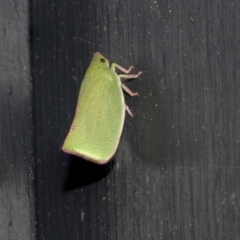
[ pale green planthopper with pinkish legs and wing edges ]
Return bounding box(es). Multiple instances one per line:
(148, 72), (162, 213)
(62, 52), (142, 164)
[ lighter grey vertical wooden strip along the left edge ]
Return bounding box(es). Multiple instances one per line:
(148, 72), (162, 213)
(0, 0), (35, 240)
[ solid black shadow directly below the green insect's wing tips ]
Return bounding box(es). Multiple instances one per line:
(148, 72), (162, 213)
(64, 155), (115, 191)
